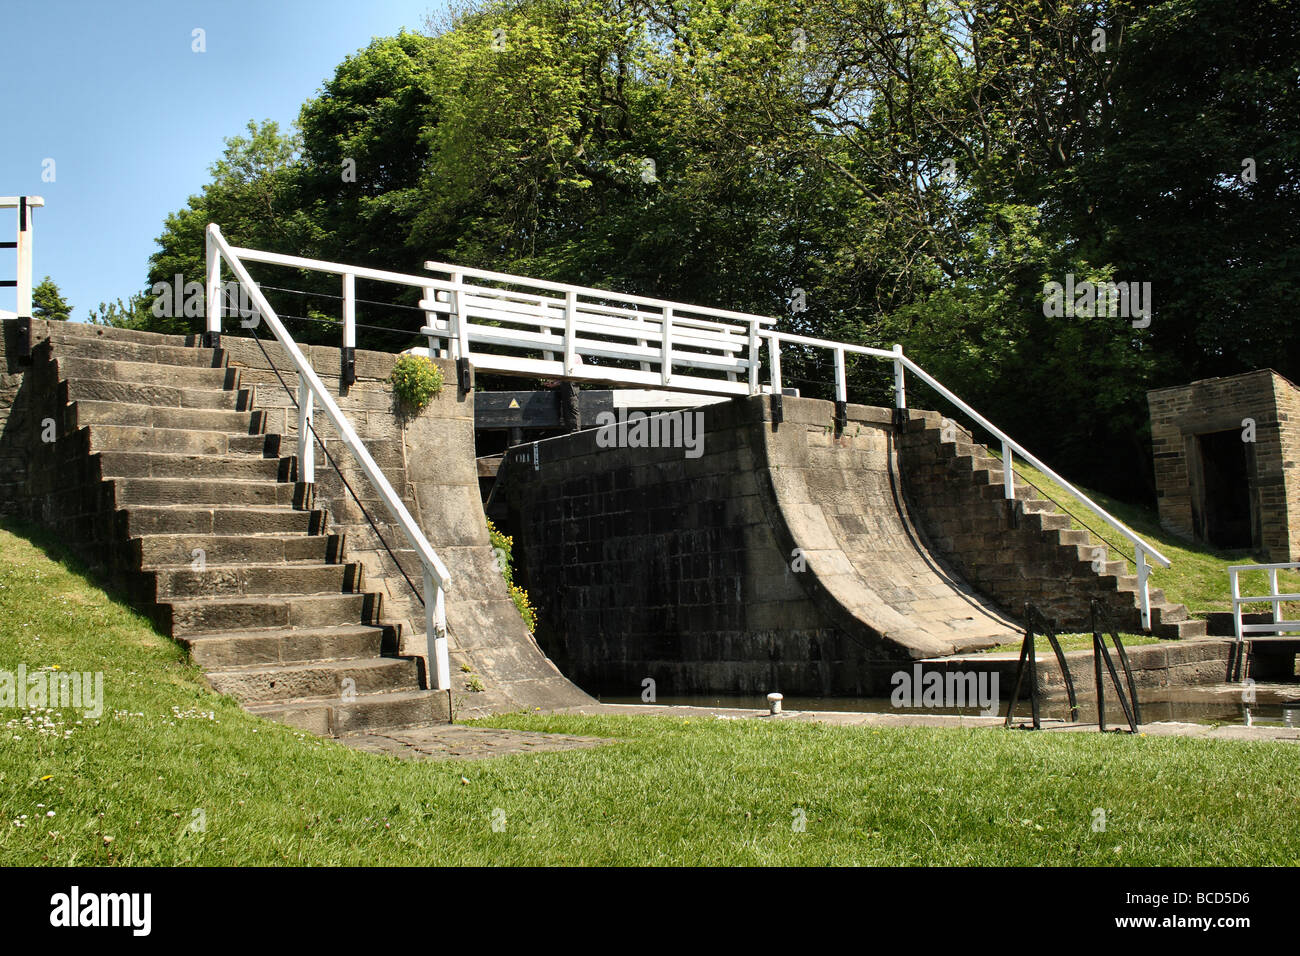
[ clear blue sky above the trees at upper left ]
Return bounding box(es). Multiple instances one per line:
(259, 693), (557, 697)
(0, 0), (445, 320)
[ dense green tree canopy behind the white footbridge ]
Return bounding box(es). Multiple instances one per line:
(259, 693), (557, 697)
(134, 0), (1300, 496)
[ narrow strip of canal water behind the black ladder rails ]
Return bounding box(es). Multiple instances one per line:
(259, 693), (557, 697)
(599, 683), (1300, 727)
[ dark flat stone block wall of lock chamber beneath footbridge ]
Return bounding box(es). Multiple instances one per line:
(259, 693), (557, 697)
(488, 399), (898, 698)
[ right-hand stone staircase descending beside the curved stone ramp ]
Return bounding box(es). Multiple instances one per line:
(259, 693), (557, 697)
(904, 411), (1206, 639)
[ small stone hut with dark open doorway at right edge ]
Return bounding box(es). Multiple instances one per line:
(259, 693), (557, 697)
(1147, 368), (1300, 562)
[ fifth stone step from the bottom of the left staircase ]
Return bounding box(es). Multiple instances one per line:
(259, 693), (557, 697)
(138, 563), (363, 601)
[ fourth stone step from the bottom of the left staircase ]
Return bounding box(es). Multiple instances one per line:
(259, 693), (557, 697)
(156, 592), (381, 637)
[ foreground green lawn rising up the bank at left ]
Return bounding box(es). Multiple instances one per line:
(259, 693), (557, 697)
(0, 520), (1300, 865)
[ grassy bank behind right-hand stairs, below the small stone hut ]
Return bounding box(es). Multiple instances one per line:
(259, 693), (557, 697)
(995, 453), (1300, 614)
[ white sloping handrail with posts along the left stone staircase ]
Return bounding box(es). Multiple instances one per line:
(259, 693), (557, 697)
(198, 224), (451, 691)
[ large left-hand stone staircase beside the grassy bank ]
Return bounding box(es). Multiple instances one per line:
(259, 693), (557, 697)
(34, 323), (450, 736)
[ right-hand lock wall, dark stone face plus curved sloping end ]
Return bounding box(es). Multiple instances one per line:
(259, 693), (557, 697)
(488, 395), (1017, 697)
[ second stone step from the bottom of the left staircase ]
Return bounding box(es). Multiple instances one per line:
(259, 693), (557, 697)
(208, 657), (420, 704)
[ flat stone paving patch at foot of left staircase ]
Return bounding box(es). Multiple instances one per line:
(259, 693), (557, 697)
(339, 723), (615, 760)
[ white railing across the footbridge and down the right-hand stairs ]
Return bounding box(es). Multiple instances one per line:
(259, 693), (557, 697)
(200, 226), (1170, 631)
